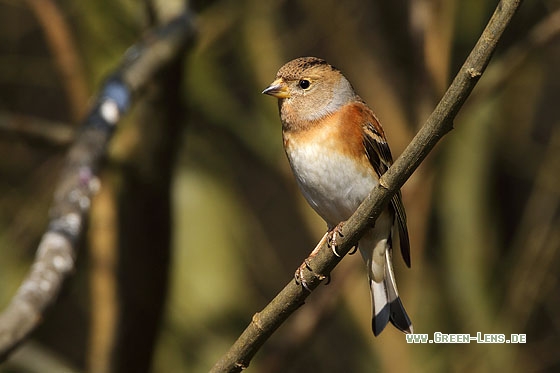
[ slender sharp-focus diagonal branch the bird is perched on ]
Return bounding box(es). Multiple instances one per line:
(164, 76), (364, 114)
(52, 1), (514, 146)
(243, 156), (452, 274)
(212, 0), (522, 372)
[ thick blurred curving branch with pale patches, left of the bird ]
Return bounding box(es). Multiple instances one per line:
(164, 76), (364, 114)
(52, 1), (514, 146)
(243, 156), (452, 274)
(0, 13), (194, 361)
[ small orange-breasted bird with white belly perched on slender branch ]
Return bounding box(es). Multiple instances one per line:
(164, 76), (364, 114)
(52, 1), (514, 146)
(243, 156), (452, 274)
(262, 57), (413, 336)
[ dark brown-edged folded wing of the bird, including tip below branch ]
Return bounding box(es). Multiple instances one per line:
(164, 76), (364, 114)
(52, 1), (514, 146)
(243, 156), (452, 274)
(360, 103), (410, 267)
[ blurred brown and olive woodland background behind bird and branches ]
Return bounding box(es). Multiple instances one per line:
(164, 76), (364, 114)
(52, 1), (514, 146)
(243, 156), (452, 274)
(0, 0), (560, 372)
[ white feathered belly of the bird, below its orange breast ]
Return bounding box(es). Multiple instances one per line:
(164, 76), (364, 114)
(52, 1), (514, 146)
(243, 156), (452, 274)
(286, 143), (377, 227)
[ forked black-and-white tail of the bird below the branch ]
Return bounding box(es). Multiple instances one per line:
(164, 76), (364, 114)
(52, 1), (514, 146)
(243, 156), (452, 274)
(368, 247), (414, 336)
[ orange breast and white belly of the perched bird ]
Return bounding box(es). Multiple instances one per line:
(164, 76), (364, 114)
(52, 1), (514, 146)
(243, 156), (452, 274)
(284, 101), (377, 225)
